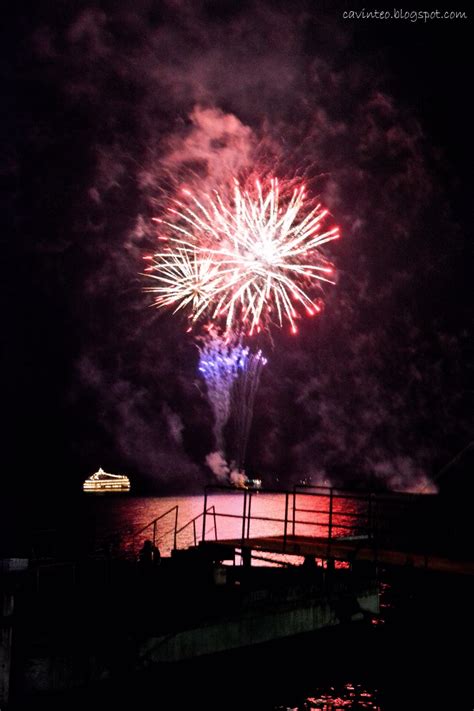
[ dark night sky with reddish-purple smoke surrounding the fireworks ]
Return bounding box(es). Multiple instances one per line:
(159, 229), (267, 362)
(1, 0), (473, 491)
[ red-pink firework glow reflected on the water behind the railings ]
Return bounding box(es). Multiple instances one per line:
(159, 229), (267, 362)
(86, 490), (366, 555)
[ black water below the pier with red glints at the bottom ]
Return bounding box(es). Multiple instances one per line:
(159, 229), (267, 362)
(5, 570), (474, 711)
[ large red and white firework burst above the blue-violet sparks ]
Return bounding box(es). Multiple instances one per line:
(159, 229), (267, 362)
(145, 179), (339, 335)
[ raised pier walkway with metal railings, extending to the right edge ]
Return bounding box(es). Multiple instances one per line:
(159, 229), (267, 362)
(196, 486), (474, 575)
